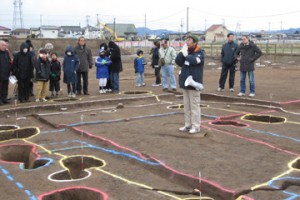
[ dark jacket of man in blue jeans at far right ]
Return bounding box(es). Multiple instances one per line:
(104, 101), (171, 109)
(235, 41), (262, 72)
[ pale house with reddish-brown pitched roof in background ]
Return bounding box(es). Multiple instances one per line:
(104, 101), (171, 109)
(205, 24), (229, 42)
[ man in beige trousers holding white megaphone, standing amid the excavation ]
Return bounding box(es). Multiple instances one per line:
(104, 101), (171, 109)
(175, 35), (206, 137)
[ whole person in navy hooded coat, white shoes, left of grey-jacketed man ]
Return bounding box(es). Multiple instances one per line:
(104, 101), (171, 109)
(63, 45), (79, 98)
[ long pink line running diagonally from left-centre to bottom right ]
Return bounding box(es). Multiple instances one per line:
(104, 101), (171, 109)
(73, 127), (252, 200)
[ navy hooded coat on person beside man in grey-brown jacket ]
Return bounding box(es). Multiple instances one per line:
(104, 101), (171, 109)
(63, 46), (79, 84)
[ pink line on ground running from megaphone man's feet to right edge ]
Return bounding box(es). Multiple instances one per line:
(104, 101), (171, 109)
(202, 126), (300, 157)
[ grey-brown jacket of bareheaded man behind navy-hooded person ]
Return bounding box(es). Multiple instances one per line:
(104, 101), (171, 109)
(75, 44), (93, 72)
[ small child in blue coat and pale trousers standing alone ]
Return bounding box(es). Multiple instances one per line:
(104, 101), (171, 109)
(134, 50), (146, 87)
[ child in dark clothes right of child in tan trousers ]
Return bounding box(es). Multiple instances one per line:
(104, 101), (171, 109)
(49, 52), (61, 97)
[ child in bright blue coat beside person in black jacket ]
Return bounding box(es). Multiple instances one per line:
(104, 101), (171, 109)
(95, 48), (111, 94)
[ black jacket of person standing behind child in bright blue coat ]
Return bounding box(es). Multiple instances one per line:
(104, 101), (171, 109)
(108, 41), (123, 73)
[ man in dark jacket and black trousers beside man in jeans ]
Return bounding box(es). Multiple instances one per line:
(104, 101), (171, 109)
(217, 33), (238, 92)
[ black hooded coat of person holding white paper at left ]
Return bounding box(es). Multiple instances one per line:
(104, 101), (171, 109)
(12, 43), (34, 79)
